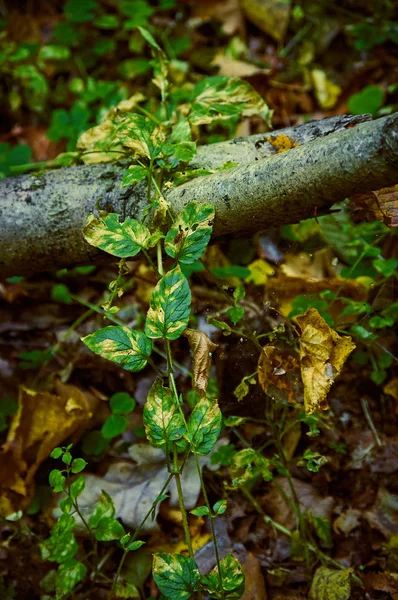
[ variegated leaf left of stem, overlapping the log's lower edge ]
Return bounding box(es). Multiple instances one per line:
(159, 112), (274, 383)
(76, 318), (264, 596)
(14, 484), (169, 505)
(83, 213), (151, 258)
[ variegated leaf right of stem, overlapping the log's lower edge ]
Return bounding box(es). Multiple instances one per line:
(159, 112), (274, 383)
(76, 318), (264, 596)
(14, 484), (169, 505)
(164, 202), (214, 265)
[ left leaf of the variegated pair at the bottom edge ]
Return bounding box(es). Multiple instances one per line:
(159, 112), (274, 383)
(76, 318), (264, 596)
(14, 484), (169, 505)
(152, 552), (200, 600)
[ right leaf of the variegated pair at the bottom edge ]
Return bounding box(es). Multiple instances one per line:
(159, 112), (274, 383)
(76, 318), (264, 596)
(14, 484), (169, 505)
(201, 554), (245, 600)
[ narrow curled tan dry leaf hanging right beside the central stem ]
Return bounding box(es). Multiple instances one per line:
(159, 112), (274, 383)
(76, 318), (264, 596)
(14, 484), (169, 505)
(184, 329), (217, 396)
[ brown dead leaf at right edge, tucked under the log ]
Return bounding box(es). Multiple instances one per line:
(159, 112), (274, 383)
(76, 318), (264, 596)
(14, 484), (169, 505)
(350, 184), (398, 227)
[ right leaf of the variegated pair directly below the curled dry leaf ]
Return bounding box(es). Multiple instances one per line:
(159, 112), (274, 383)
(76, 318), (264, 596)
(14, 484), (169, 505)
(187, 398), (222, 454)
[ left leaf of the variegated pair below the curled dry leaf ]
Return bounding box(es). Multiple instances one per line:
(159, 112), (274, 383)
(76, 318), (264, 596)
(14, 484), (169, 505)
(144, 378), (185, 447)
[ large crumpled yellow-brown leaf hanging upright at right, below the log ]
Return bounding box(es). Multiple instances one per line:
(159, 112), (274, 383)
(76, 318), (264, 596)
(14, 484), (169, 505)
(296, 308), (355, 414)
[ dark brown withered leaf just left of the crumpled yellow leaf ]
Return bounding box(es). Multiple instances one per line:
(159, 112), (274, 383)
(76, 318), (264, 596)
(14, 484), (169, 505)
(257, 345), (300, 404)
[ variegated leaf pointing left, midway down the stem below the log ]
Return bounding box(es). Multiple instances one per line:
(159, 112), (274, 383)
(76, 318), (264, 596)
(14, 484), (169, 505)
(82, 325), (152, 371)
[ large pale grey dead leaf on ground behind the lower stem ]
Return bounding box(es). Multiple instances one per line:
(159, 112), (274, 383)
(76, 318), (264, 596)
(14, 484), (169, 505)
(71, 438), (228, 532)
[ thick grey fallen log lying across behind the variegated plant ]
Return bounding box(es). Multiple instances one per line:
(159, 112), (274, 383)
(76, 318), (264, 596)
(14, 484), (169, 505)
(0, 114), (398, 277)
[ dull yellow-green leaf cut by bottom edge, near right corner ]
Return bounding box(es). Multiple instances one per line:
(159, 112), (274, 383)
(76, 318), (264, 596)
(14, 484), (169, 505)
(309, 567), (353, 600)
